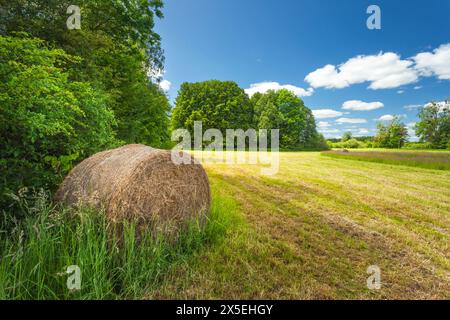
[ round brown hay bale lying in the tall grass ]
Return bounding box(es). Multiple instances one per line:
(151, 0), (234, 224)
(55, 144), (211, 230)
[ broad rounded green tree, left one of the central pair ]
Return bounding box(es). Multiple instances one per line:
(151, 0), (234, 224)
(171, 80), (253, 136)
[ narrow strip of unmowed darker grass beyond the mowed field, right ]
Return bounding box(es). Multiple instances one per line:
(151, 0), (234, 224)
(322, 150), (450, 170)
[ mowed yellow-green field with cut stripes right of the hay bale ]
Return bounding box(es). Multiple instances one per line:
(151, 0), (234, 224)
(146, 152), (450, 299)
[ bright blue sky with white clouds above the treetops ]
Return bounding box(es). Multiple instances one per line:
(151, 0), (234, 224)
(156, 0), (450, 137)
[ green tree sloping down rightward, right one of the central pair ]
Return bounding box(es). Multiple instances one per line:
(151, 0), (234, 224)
(252, 89), (327, 149)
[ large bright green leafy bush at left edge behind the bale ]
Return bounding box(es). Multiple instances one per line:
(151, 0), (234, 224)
(0, 37), (116, 210)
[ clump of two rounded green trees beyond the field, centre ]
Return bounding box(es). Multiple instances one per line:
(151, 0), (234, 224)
(171, 80), (327, 150)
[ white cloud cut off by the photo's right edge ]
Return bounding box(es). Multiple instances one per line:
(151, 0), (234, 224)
(413, 43), (450, 80)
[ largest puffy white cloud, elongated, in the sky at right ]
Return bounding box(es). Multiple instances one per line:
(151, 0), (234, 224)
(305, 52), (418, 90)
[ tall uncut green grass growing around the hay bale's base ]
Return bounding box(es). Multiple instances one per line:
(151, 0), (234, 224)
(0, 192), (234, 299)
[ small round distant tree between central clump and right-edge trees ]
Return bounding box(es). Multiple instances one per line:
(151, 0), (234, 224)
(374, 117), (408, 148)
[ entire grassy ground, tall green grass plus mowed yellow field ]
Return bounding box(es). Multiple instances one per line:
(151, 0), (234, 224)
(0, 152), (450, 299)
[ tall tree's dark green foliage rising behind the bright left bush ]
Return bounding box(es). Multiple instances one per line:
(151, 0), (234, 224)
(0, 0), (170, 147)
